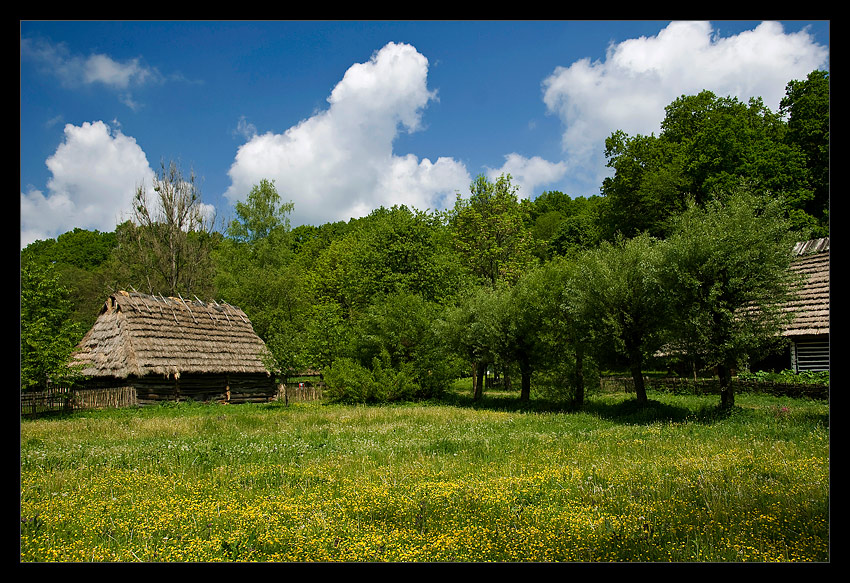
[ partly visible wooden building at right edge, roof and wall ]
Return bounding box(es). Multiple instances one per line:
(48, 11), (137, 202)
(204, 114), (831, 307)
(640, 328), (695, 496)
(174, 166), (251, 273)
(782, 237), (829, 372)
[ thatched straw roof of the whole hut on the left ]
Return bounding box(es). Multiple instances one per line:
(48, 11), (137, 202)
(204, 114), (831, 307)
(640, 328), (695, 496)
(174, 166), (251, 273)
(73, 291), (268, 378)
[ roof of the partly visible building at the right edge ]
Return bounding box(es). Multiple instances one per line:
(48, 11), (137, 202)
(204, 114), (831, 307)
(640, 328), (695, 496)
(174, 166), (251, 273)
(783, 237), (829, 336)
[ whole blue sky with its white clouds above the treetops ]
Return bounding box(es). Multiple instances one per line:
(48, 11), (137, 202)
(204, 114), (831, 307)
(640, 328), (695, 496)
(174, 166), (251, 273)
(20, 21), (829, 247)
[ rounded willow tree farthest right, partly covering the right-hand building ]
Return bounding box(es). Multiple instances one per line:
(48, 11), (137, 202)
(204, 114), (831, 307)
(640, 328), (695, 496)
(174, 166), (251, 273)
(664, 187), (800, 408)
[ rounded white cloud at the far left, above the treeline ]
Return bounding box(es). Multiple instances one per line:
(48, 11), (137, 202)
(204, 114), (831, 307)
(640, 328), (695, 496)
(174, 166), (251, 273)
(21, 121), (154, 248)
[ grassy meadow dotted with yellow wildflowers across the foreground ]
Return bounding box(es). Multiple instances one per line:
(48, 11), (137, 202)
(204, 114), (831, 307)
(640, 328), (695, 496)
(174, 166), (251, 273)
(21, 393), (830, 562)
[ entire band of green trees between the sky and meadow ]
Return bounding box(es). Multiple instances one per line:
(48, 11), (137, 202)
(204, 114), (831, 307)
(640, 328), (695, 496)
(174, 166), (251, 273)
(21, 71), (829, 406)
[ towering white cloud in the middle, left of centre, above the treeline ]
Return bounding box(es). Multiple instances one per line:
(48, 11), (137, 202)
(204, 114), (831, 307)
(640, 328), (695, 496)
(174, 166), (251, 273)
(225, 43), (471, 225)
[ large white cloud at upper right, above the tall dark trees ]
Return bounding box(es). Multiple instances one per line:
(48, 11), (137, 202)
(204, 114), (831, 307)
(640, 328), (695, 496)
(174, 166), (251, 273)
(543, 22), (829, 192)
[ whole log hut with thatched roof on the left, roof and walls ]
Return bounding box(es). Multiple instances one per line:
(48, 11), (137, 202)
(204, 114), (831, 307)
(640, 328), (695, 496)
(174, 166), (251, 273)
(71, 291), (277, 406)
